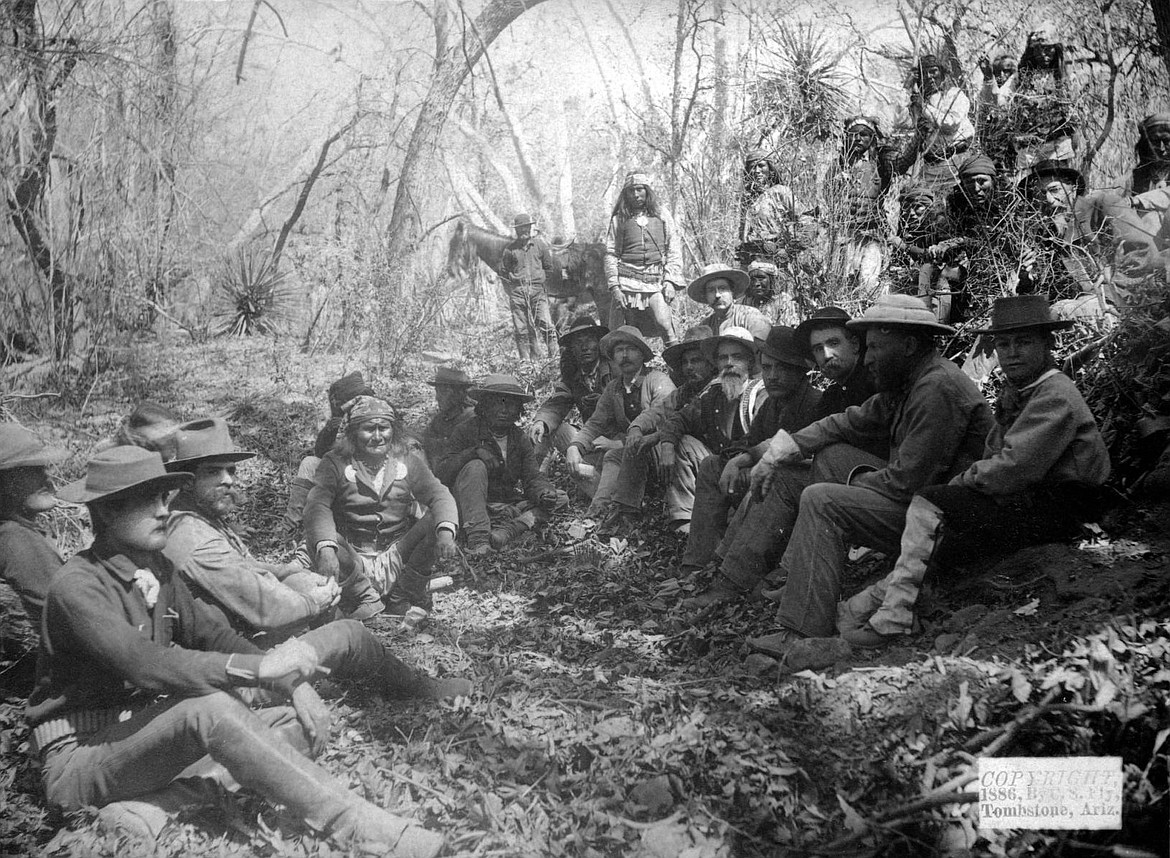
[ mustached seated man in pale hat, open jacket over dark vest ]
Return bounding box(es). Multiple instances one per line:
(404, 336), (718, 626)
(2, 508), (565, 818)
(565, 324), (674, 531)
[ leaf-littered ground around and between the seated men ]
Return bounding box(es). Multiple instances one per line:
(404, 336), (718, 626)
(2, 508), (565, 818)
(0, 341), (1170, 858)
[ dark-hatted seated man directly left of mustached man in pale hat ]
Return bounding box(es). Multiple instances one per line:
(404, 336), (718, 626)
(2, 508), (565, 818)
(528, 316), (613, 462)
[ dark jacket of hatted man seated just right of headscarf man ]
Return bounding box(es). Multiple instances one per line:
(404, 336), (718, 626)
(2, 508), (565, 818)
(435, 418), (556, 503)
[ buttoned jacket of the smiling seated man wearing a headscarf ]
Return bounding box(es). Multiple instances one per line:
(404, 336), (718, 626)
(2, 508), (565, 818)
(304, 449), (459, 552)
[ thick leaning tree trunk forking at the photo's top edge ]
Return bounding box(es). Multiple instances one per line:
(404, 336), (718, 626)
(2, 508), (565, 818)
(387, 0), (544, 260)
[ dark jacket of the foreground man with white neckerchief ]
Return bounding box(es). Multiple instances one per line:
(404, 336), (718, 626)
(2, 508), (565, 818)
(27, 540), (263, 735)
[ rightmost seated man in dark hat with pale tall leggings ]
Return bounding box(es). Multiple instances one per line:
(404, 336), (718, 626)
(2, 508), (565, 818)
(837, 295), (1109, 647)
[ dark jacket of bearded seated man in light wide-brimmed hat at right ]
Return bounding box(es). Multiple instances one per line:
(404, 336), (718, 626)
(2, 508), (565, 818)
(792, 352), (993, 503)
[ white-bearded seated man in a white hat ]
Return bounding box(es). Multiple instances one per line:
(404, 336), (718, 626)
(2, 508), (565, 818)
(659, 325), (766, 533)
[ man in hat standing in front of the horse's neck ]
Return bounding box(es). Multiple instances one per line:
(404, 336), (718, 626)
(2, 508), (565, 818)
(500, 213), (557, 361)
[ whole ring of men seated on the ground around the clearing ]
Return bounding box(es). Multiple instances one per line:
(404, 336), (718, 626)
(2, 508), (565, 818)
(0, 268), (1109, 856)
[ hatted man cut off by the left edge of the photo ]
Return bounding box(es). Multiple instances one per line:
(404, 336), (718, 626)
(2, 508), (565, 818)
(0, 423), (69, 633)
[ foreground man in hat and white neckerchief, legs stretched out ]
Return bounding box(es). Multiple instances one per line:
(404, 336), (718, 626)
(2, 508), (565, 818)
(26, 446), (443, 857)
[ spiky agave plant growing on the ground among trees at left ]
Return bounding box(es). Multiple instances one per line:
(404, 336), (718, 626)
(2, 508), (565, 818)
(215, 248), (291, 337)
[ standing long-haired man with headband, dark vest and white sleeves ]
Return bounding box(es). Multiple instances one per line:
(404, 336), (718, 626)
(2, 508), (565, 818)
(605, 170), (682, 345)
